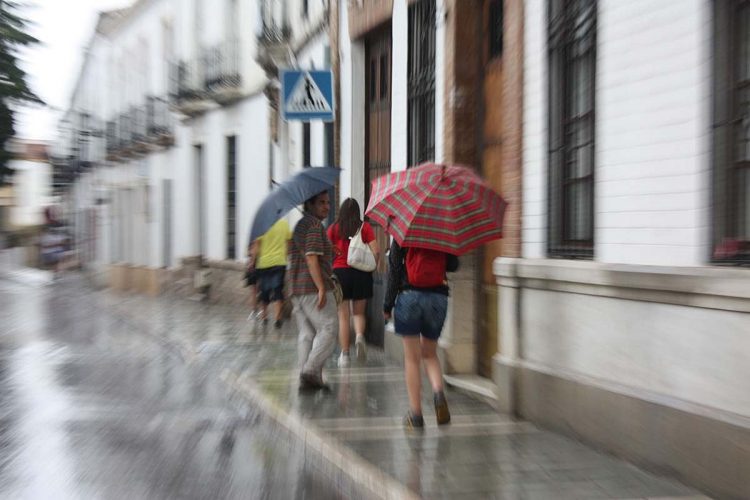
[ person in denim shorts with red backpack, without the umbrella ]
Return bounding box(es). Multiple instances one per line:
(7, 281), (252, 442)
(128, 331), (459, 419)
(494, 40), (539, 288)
(383, 241), (458, 429)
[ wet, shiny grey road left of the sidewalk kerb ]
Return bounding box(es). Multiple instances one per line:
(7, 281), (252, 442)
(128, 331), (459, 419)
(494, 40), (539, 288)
(0, 276), (338, 499)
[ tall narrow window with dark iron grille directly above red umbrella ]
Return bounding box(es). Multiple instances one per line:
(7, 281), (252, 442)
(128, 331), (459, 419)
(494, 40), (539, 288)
(408, 0), (436, 166)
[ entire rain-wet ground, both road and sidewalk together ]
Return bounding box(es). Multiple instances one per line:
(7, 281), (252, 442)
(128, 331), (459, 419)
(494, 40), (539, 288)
(0, 270), (704, 499)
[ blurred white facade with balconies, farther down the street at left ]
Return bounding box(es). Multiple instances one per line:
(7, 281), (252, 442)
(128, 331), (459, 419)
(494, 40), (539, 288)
(61, 0), (328, 290)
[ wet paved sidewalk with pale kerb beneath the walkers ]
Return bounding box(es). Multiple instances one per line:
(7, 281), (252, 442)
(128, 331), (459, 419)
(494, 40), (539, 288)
(106, 293), (705, 499)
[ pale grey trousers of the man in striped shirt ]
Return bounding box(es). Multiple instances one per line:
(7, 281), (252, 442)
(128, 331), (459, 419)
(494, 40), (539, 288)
(292, 292), (339, 376)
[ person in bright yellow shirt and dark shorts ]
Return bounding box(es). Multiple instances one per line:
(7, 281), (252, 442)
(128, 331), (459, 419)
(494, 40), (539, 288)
(254, 219), (292, 328)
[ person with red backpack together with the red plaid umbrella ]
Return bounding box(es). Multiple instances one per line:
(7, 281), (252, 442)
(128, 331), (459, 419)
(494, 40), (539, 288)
(366, 163), (506, 428)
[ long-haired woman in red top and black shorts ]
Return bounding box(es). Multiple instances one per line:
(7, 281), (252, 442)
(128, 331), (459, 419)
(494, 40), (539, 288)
(328, 198), (378, 368)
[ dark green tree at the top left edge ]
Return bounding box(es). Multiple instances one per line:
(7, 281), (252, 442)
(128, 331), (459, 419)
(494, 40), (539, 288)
(0, 0), (42, 185)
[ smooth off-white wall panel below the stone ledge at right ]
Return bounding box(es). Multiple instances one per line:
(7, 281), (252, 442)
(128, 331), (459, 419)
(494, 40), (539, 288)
(521, 289), (750, 417)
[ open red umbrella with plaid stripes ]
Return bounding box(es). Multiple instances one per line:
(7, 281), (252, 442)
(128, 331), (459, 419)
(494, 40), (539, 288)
(365, 163), (507, 255)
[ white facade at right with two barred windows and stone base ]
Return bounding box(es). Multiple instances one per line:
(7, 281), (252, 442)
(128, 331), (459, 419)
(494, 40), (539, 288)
(495, 0), (750, 497)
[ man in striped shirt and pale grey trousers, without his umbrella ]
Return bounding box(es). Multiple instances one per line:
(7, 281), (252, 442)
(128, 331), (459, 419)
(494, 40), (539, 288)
(289, 191), (339, 390)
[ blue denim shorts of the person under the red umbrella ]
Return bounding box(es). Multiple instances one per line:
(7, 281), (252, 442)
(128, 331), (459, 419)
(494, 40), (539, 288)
(393, 290), (448, 340)
